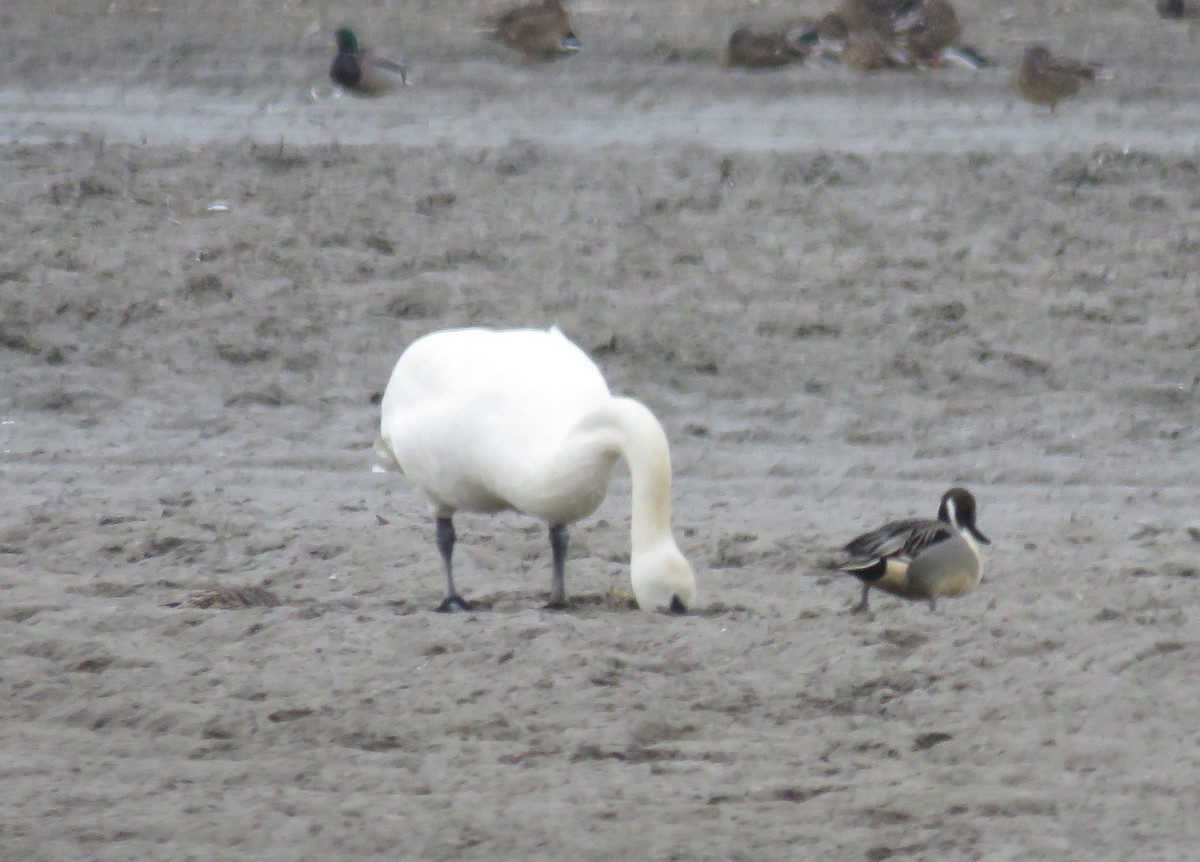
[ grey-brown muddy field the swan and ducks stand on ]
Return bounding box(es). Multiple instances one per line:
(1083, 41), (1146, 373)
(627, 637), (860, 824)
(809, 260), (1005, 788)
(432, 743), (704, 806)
(0, 0), (1200, 862)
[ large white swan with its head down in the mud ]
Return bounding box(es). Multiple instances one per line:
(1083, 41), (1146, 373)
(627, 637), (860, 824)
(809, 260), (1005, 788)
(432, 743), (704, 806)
(377, 328), (696, 612)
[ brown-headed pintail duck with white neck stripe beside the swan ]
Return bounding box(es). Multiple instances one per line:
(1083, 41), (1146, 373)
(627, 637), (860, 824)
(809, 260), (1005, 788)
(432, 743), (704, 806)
(838, 487), (991, 612)
